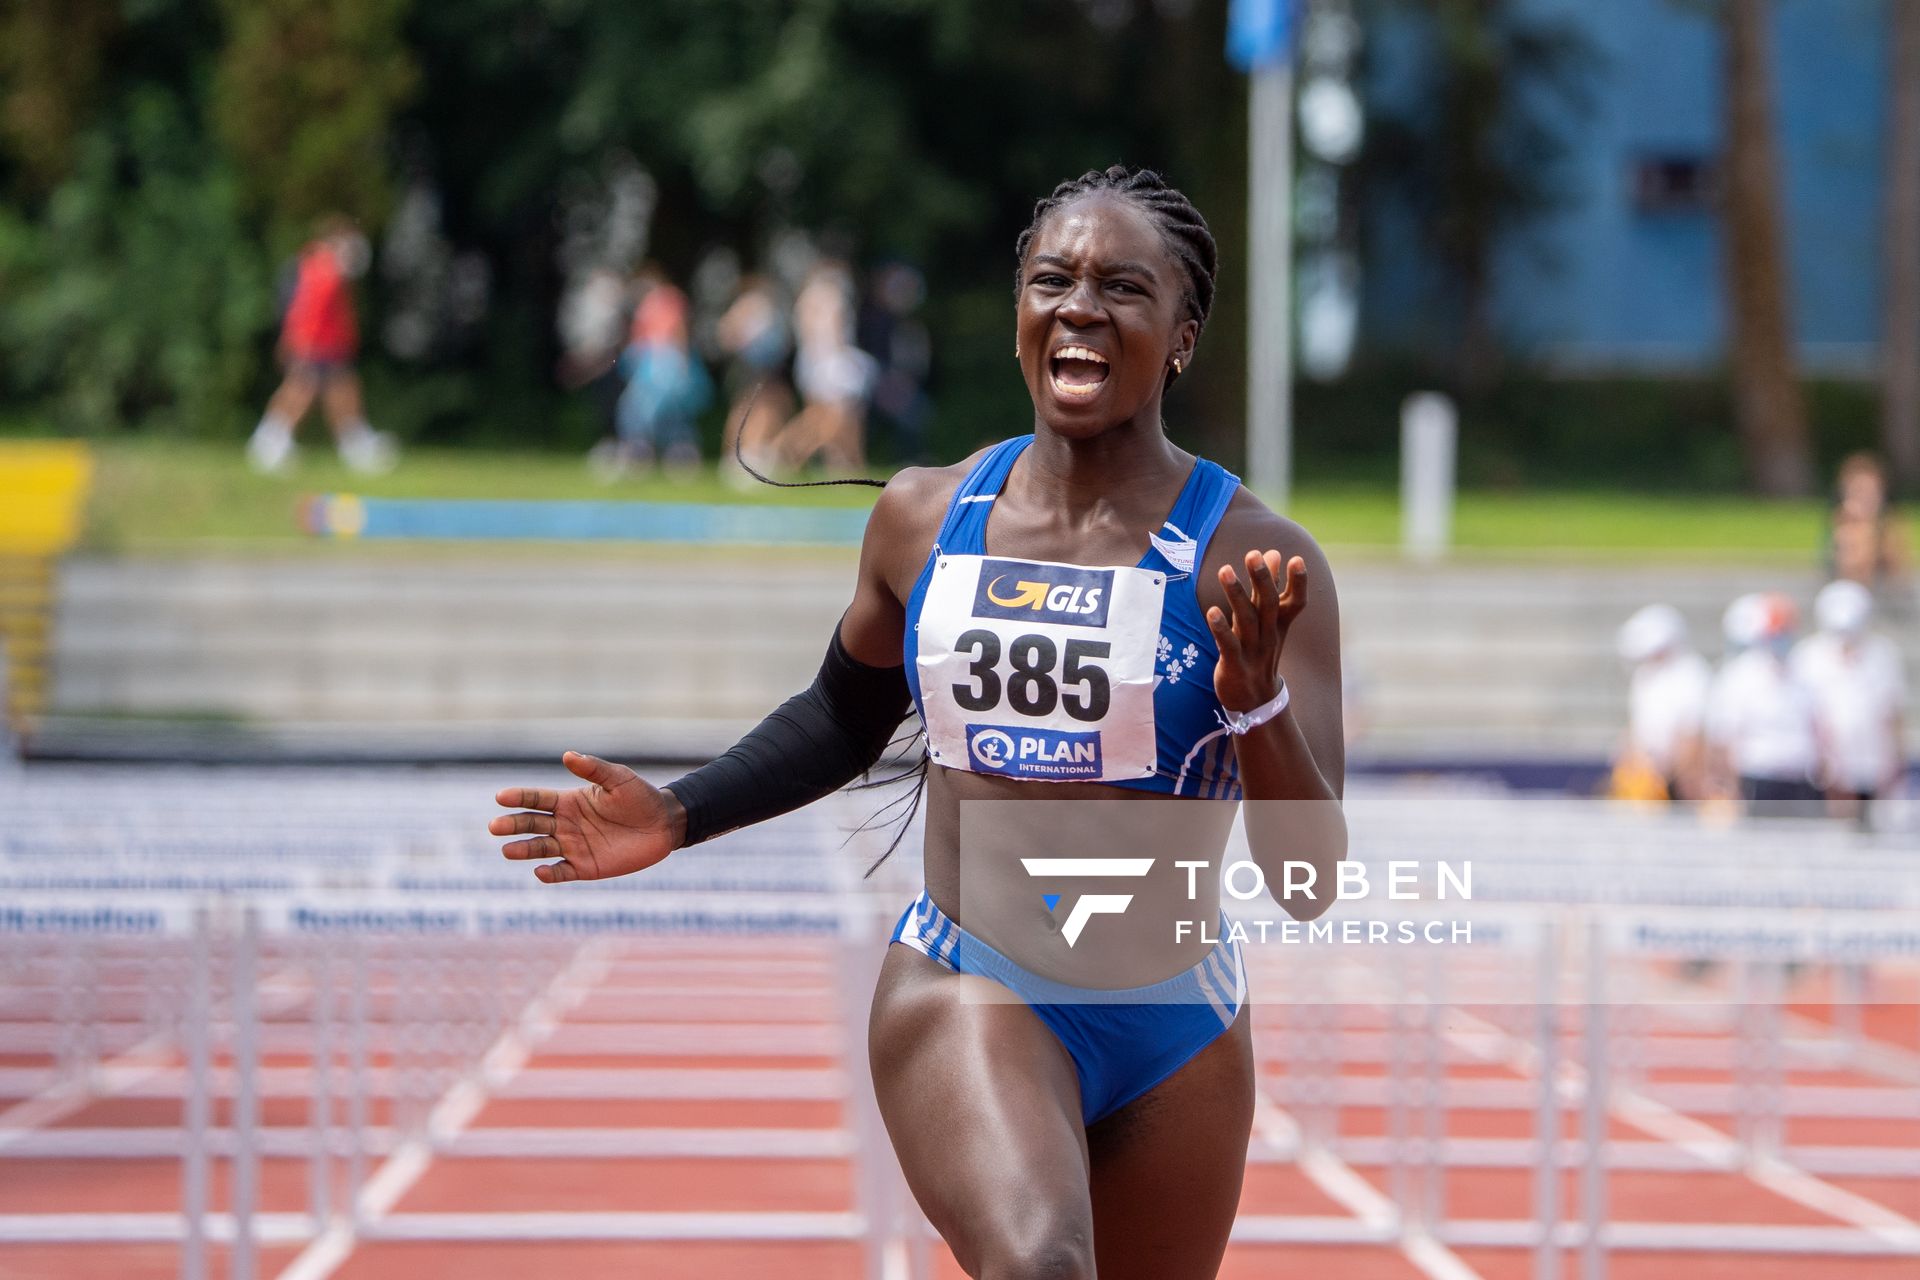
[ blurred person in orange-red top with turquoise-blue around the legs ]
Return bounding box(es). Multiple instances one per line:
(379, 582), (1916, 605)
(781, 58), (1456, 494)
(593, 273), (712, 480)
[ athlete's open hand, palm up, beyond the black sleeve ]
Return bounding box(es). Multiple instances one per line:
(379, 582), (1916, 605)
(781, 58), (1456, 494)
(486, 750), (685, 885)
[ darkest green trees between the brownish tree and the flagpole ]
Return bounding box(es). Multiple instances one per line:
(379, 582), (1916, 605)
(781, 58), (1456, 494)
(403, 0), (1246, 451)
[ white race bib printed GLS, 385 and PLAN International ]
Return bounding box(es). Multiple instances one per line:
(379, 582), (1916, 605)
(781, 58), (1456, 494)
(918, 555), (1167, 783)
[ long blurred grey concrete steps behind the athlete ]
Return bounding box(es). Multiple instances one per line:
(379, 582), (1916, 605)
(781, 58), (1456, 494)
(33, 549), (1920, 756)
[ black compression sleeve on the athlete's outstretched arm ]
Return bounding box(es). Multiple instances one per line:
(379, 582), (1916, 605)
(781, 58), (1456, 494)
(666, 628), (912, 848)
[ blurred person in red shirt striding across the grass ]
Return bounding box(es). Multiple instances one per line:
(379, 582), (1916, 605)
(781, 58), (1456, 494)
(246, 215), (394, 474)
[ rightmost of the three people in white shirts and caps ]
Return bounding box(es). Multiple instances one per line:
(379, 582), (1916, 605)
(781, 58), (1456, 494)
(1791, 580), (1907, 825)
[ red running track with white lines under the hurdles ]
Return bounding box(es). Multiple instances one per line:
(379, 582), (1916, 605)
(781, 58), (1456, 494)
(0, 938), (1920, 1280)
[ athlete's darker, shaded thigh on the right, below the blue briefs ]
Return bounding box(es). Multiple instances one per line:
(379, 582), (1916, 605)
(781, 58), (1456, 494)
(1087, 1006), (1254, 1280)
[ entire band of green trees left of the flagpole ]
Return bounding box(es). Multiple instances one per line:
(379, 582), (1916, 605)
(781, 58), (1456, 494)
(0, 0), (1244, 451)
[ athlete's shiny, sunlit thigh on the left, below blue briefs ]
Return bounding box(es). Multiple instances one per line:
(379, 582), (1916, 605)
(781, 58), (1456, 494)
(868, 946), (1092, 1276)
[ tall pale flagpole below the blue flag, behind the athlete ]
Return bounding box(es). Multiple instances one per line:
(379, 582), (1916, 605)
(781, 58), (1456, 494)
(1246, 59), (1294, 512)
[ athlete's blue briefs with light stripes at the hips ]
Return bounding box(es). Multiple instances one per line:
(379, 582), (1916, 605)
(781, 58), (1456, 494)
(893, 890), (1246, 1125)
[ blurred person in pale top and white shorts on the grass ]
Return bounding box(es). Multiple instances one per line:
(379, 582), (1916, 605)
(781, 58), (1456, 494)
(770, 263), (876, 472)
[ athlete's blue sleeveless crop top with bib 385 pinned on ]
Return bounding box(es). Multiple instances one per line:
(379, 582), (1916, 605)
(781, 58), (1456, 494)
(904, 436), (1240, 800)
